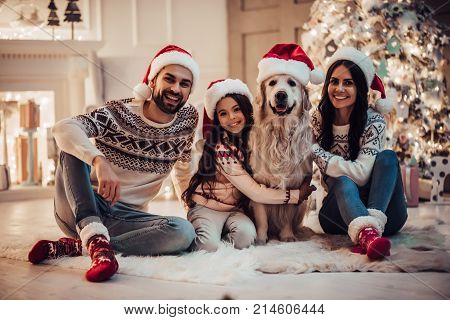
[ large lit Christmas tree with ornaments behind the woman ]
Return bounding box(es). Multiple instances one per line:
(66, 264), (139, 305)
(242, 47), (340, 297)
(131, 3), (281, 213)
(302, 0), (450, 177)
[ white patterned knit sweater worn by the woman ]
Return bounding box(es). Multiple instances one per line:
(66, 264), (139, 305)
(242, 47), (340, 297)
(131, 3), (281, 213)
(311, 108), (386, 186)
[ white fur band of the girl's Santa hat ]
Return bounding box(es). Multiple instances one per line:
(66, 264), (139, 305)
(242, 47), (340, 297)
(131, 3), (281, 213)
(204, 79), (253, 119)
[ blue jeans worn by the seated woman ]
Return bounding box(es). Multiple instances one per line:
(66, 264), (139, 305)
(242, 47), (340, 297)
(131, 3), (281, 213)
(319, 150), (408, 236)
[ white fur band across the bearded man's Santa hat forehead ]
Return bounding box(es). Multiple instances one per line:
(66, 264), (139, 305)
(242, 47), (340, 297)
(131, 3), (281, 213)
(148, 51), (200, 91)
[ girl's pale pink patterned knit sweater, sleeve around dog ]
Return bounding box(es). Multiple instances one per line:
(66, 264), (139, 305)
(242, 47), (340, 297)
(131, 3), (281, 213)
(192, 138), (300, 211)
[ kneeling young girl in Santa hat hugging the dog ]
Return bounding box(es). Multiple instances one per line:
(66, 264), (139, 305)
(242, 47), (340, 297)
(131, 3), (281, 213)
(182, 79), (312, 251)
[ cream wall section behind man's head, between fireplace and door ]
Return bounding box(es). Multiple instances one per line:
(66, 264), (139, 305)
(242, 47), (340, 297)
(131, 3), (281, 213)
(98, 0), (228, 104)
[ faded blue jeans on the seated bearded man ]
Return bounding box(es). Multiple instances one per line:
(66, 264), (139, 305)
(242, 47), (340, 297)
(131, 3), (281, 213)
(55, 152), (195, 255)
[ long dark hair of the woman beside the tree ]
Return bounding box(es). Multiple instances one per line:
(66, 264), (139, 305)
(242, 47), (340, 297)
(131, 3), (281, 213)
(318, 60), (369, 161)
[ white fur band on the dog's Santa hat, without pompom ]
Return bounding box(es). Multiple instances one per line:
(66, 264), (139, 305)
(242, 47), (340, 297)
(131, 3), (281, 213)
(256, 58), (311, 86)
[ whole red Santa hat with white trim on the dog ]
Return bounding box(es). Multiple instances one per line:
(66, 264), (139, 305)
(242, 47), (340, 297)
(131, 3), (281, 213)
(256, 43), (325, 86)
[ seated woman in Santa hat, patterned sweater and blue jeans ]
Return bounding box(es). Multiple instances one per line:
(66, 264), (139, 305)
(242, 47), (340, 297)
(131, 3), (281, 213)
(312, 47), (407, 259)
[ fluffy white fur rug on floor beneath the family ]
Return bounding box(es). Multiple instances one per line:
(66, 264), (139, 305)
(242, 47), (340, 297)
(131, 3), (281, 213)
(0, 215), (450, 285)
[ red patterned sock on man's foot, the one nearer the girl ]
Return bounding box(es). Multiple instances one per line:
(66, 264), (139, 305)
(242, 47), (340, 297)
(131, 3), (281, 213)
(86, 235), (119, 282)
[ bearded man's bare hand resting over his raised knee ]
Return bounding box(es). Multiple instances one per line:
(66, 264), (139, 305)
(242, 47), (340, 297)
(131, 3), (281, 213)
(92, 156), (120, 205)
